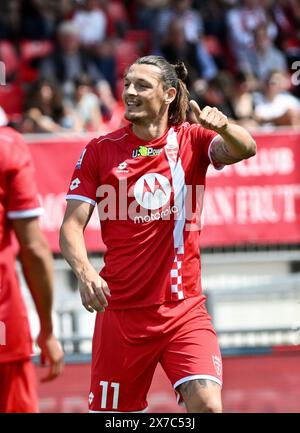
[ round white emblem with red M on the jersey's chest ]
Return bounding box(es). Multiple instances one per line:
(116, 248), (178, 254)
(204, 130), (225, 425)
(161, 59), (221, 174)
(134, 173), (171, 209)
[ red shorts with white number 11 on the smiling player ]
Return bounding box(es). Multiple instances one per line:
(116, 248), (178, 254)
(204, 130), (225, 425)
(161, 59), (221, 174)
(89, 297), (222, 412)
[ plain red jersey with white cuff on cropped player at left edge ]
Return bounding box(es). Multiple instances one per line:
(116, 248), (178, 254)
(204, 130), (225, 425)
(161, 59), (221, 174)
(0, 127), (42, 362)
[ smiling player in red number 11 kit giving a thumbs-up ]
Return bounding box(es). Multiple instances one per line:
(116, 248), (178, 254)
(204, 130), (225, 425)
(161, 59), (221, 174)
(60, 56), (256, 412)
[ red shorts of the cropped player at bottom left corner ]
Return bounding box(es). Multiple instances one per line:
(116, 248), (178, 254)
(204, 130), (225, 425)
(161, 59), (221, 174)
(0, 359), (38, 413)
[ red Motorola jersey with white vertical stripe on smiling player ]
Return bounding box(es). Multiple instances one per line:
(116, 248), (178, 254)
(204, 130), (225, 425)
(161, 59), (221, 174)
(66, 123), (217, 309)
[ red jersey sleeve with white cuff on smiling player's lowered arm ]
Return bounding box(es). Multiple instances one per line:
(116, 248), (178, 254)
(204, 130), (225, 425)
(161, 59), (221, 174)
(66, 140), (100, 206)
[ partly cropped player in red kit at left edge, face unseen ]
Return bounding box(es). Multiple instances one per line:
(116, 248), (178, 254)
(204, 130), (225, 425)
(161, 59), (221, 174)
(0, 127), (63, 413)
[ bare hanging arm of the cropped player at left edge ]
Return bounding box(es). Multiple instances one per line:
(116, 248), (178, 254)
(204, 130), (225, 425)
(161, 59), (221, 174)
(12, 218), (63, 381)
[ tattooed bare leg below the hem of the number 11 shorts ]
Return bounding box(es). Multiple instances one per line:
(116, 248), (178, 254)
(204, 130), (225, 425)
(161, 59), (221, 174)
(178, 379), (222, 413)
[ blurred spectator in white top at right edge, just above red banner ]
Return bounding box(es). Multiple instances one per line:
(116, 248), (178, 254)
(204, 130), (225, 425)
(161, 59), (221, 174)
(254, 71), (300, 126)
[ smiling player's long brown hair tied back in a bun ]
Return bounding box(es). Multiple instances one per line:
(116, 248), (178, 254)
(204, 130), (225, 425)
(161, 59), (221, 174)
(134, 56), (189, 125)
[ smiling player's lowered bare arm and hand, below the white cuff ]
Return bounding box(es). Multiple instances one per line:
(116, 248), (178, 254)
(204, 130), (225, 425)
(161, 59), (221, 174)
(60, 200), (110, 313)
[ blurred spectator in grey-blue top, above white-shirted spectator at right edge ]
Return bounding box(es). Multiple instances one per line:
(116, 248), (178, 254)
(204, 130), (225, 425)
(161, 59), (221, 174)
(242, 24), (287, 81)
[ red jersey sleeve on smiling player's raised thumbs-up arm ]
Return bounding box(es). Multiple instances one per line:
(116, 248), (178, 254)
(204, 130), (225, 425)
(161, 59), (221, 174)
(190, 124), (223, 170)
